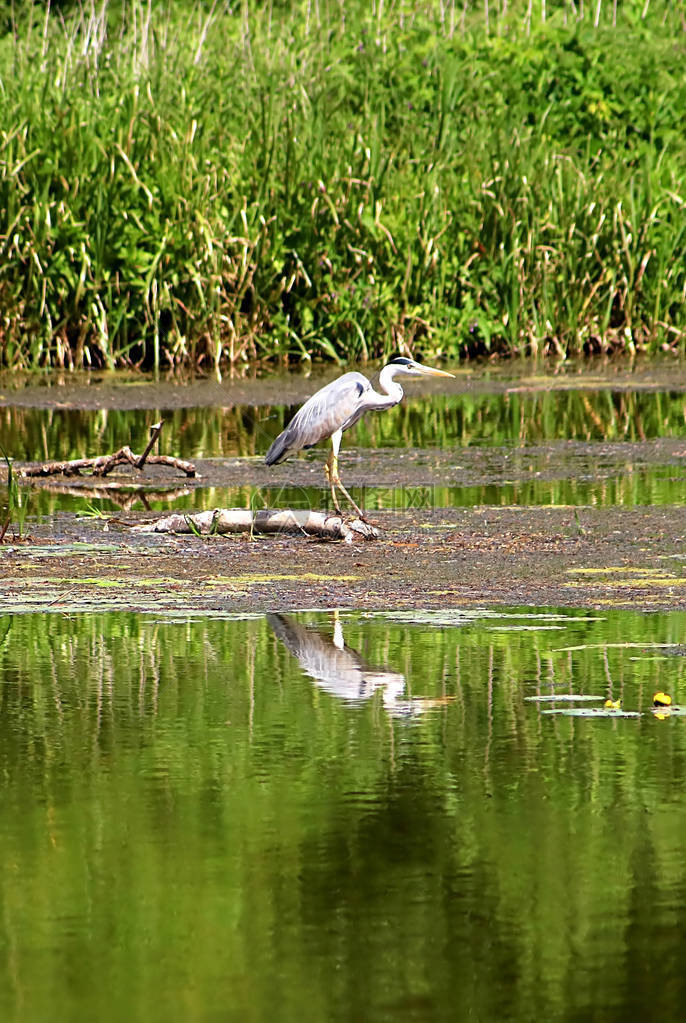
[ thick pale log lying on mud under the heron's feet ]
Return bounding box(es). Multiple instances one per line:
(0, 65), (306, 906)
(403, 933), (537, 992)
(137, 508), (378, 543)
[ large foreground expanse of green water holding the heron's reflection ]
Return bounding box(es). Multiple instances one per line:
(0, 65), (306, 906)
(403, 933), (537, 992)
(0, 610), (686, 1021)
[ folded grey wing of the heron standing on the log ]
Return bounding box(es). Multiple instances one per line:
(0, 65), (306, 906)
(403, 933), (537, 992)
(265, 372), (371, 465)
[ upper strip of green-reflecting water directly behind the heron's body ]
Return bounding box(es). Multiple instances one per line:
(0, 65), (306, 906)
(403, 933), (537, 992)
(0, 391), (685, 461)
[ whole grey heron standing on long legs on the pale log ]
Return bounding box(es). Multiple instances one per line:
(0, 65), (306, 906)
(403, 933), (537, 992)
(265, 357), (453, 520)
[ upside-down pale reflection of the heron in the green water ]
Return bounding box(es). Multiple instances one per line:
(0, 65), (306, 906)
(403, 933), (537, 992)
(267, 614), (452, 717)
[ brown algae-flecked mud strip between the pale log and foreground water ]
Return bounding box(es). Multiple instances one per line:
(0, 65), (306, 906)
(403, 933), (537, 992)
(0, 506), (686, 615)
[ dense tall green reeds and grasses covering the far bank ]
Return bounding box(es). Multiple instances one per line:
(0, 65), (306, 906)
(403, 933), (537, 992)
(0, 0), (686, 367)
